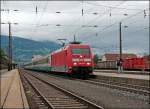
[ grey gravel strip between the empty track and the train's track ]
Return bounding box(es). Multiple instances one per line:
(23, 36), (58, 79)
(25, 70), (149, 109)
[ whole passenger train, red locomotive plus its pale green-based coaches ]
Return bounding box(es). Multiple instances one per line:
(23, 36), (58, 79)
(25, 44), (94, 77)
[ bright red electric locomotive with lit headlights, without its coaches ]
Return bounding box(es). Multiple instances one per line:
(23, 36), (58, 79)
(50, 44), (94, 75)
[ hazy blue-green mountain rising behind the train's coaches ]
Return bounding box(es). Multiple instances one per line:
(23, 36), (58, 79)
(1, 35), (60, 61)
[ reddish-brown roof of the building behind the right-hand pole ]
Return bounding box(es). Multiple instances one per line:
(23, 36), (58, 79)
(102, 53), (137, 61)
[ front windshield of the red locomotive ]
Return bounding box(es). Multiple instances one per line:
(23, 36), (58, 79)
(72, 48), (90, 55)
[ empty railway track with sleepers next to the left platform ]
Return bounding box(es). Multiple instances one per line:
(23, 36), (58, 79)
(22, 70), (103, 109)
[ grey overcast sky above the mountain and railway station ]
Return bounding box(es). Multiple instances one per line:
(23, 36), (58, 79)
(1, 1), (149, 54)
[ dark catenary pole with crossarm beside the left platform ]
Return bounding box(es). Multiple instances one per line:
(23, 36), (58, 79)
(1, 22), (18, 71)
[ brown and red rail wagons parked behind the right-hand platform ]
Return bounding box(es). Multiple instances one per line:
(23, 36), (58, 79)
(96, 56), (150, 71)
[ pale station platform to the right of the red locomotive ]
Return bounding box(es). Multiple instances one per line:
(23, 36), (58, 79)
(93, 71), (150, 86)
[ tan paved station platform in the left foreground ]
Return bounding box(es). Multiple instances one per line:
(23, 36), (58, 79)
(0, 69), (29, 109)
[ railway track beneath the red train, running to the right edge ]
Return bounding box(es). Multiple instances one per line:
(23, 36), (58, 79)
(26, 70), (150, 96)
